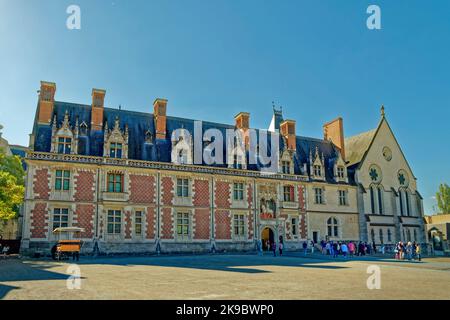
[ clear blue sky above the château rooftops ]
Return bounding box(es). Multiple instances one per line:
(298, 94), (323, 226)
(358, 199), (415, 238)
(0, 0), (450, 213)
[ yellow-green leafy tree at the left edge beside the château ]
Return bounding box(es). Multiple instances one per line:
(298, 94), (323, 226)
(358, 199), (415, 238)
(0, 148), (25, 220)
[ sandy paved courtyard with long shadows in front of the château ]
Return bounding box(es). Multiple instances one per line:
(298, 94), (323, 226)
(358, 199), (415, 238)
(0, 255), (450, 299)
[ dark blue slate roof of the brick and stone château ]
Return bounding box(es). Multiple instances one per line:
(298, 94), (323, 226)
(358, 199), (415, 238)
(34, 101), (354, 184)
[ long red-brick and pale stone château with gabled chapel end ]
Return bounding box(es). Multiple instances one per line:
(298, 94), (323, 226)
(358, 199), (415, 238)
(22, 82), (425, 253)
